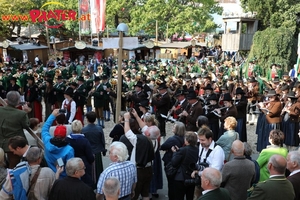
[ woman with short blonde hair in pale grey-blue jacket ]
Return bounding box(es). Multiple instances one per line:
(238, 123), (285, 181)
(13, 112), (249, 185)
(216, 117), (239, 161)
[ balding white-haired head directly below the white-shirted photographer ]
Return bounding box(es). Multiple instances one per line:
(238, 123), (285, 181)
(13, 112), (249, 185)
(201, 167), (222, 190)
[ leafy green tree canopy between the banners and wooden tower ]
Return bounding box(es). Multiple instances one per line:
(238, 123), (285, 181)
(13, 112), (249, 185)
(107, 0), (222, 37)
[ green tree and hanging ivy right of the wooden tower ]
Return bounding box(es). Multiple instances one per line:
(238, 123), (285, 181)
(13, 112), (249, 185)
(241, 0), (300, 71)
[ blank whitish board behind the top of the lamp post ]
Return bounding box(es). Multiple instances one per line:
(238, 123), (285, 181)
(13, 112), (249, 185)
(102, 37), (139, 49)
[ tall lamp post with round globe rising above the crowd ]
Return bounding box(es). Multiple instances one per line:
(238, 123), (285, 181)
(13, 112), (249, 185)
(115, 23), (128, 123)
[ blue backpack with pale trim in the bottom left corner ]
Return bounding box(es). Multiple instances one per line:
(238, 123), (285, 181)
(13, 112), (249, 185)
(9, 161), (31, 200)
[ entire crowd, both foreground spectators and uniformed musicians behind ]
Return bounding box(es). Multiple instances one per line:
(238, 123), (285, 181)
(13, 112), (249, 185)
(0, 51), (300, 200)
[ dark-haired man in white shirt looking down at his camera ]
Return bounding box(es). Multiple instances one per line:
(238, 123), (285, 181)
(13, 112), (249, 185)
(191, 126), (225, 199)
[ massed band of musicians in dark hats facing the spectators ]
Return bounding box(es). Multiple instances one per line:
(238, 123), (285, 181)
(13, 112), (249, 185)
(0, 55), (300, 151)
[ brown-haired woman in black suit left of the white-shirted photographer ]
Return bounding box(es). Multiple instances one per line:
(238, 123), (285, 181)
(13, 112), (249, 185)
(171, 131), (199, 200)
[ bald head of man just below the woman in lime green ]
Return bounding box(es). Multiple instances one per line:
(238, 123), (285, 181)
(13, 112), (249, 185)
(268, 154), (287, 175)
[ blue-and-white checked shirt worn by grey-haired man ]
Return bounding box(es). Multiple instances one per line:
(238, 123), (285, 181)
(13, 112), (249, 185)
(97, 161), (137, 198)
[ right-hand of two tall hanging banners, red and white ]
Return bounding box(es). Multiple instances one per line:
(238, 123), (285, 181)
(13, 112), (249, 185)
(90, 0), (106, 34)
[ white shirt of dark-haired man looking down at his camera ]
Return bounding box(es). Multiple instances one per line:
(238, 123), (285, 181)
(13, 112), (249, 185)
(198, 141), (225, 176)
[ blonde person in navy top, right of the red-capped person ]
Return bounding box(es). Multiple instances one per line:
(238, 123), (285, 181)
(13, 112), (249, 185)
(66, 120), (95, 188)
